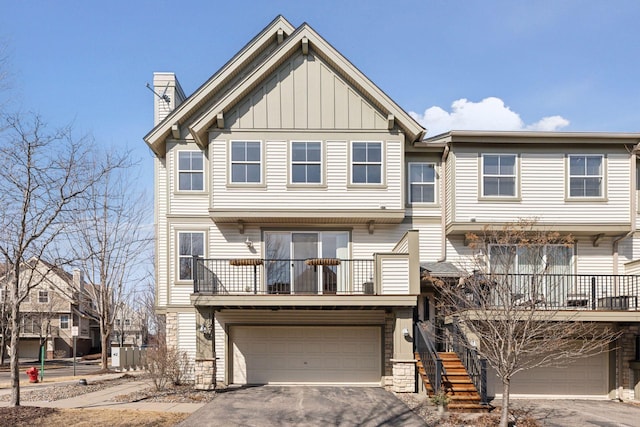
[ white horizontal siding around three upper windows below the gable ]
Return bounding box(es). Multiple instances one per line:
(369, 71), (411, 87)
(211, 137), (404, 210)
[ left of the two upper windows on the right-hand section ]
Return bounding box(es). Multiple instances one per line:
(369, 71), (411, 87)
(482, 154), (517, 197)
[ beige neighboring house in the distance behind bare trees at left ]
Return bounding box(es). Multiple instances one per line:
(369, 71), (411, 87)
(0, 259), (92, 359)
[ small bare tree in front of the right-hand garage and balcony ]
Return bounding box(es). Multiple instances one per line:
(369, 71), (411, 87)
(436, 220), (618, 427)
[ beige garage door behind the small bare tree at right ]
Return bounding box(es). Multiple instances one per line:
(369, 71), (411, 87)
(489, 353), (609, 397)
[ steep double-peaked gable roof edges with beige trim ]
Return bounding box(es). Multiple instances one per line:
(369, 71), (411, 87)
(145, 16), (425, 155)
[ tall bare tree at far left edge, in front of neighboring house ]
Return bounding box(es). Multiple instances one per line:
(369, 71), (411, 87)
(0, 115), (100, 406)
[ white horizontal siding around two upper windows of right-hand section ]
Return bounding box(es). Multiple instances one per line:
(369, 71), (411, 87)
(454, 149), (630, 224)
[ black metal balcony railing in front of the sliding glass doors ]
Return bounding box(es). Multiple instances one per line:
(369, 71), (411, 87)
(193, 257), (376, 295)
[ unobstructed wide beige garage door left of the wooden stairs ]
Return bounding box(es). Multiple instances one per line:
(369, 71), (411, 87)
(231, 326), (382, 385)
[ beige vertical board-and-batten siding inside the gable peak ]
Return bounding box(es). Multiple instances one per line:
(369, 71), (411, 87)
(225, 52), (387, 130)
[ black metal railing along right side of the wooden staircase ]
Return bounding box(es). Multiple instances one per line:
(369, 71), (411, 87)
(447, 316), (488, 405)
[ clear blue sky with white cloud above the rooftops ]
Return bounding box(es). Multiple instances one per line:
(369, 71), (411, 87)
(0, 0), (640, 187)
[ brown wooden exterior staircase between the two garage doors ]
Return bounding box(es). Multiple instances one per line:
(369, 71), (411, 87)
(415, 352), (491, 412)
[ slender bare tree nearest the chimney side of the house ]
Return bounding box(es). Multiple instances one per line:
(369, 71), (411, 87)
(71, 154), (152, 369)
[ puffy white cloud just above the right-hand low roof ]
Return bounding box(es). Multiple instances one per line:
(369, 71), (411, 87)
(409, 97), (569, 136)
